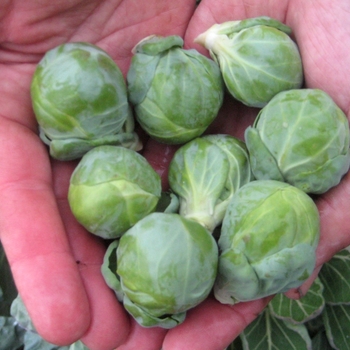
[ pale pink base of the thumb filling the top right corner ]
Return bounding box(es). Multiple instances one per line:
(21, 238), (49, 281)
(288, 0), (350, 112)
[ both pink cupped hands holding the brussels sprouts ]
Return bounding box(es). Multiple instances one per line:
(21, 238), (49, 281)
(0, 0), (350, 350)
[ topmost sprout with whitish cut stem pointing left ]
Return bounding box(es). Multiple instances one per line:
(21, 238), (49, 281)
(195, 17), (303, 107)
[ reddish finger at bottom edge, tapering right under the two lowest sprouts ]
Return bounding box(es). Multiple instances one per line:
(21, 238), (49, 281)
(163, 298), (269, 350)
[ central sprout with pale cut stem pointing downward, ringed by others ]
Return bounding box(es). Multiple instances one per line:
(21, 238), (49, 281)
(168, 135), (252, 232)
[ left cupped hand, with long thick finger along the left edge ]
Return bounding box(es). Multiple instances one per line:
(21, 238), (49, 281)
(0, 0), (195, 350)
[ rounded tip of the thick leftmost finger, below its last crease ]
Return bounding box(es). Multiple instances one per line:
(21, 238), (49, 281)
(12, 254), (90, 346)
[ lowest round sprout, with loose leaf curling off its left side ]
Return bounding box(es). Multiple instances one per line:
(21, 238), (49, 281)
(101, 213), (218, 329)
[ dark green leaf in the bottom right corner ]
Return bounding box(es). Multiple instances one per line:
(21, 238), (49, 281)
(323, 304), (350, 350)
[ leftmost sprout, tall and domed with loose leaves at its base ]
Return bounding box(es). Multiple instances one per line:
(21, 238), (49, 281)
(31, 42), (140, 160)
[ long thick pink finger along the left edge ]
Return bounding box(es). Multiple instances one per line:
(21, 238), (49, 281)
(0, 118), (90, 345)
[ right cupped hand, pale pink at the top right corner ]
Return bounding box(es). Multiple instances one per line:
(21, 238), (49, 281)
(158, 0), (350, 350)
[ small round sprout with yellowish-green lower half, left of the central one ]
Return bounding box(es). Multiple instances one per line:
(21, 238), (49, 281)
(68, 146), (161, 238)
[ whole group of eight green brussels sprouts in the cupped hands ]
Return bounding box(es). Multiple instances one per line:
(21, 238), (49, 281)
(32, 17), (350, 328)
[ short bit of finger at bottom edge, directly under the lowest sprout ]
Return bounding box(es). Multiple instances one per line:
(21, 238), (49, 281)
(116, 320), (167, 350)
